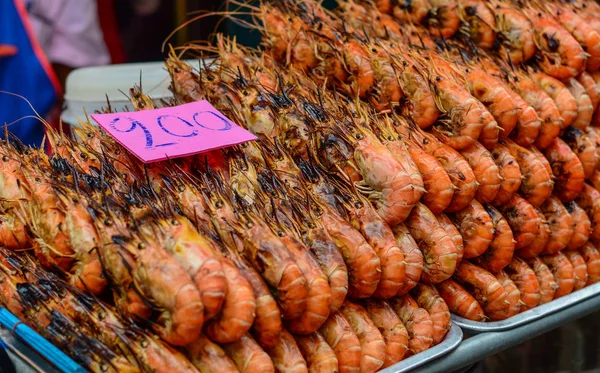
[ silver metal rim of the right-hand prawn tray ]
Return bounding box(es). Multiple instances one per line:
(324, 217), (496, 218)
(452, 283), (600, 334)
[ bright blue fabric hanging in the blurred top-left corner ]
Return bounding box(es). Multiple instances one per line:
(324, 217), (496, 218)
(0, 0), (56, 146)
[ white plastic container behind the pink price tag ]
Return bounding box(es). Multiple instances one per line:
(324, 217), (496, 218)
(61, 62), (173, 126)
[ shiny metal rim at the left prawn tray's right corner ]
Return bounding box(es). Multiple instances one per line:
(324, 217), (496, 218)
(379, 322), (463, 373)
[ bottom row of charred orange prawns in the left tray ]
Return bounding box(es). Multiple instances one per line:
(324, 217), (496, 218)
(0, 232), (450, 373)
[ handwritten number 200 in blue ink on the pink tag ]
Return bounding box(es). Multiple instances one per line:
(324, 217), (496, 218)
(110, 111), (232, 149)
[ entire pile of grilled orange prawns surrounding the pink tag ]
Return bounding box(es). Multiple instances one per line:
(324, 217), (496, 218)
(0, 0), (600, 372)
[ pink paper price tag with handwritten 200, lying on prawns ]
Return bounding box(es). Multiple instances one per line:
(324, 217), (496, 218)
(92, 101), (256, 163)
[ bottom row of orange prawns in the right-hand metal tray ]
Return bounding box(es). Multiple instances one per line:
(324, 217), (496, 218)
(436, 242), (600, 321)
